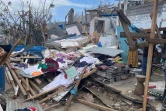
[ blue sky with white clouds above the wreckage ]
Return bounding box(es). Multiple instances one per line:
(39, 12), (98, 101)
(2, 0), (118, 21)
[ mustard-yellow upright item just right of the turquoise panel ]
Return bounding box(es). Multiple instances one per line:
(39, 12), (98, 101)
(128, 50), (138, 67)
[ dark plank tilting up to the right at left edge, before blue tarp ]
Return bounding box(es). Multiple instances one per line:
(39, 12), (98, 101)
(0, 38), (22, 67)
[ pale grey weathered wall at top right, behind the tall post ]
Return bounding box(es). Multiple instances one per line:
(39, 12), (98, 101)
(126, 1), (166, 29)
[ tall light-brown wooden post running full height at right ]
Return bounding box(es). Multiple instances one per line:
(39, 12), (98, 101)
(143, 0), (158, 111)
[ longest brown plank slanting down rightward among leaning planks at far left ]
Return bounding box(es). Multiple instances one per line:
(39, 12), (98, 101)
(6, 62), (27, 96)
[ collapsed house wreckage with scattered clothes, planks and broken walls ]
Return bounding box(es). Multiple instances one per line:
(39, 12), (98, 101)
(0, 1), (166, 111)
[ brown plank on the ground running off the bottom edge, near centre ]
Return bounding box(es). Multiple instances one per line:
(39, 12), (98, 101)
(76, 99), (117, 111)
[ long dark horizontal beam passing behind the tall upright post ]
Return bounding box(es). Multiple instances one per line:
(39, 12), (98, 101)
(120, 32), (166, 39)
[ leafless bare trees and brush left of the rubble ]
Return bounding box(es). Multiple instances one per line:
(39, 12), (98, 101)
(0, 0), (54, 45)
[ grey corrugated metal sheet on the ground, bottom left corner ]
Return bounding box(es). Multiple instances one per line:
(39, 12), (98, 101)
(6, 100), (43, 111)
